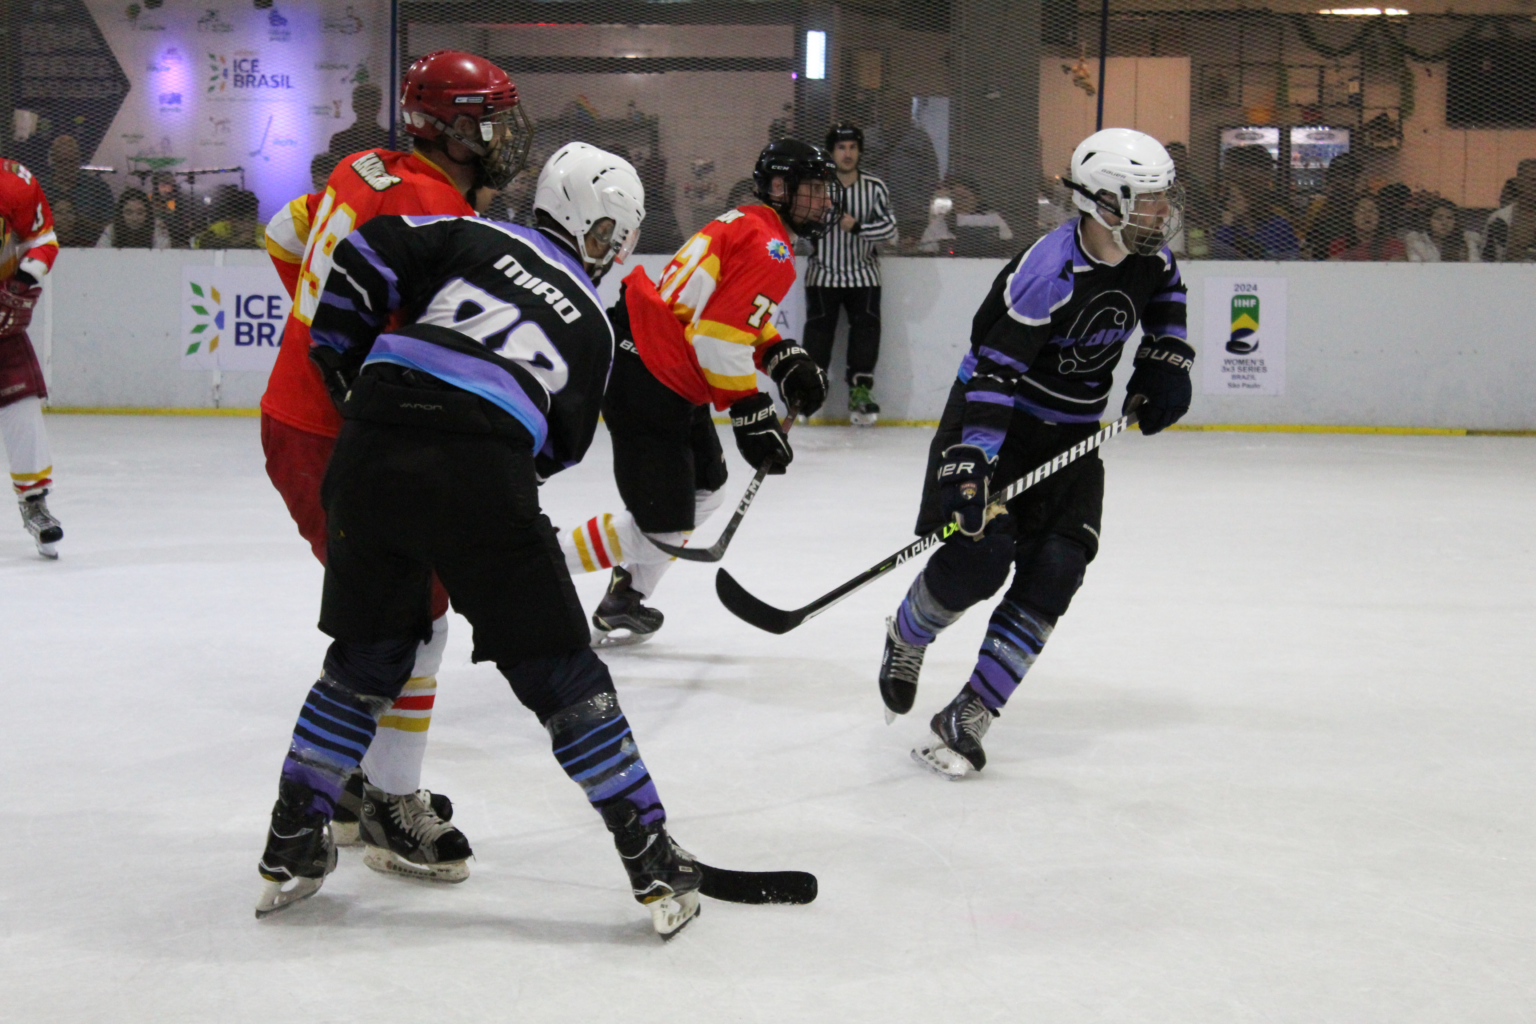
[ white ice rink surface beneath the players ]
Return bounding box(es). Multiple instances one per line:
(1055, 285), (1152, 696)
(0, 416), (1536, 1024)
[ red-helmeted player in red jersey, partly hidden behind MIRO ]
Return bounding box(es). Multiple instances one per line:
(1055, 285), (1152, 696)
(261, 51), (531, 881)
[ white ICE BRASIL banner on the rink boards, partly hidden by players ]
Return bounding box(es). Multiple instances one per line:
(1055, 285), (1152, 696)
(180, 267), (293, 372)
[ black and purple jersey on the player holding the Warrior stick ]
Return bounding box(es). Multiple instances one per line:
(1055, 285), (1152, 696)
(960, 220), (1187, 457)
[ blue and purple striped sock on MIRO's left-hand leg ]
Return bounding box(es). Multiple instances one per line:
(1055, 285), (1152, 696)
(283, 676), (390, 818)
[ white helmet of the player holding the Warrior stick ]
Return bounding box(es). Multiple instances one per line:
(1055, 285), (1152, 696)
(1066, 127), (1184, 256)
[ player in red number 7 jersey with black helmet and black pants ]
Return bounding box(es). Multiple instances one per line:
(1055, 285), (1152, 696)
(561, 140), (837, 645)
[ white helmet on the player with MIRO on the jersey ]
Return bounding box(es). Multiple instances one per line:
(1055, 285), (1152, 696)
(533, 143), (645, 276)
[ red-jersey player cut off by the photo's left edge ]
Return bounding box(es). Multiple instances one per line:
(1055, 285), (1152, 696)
(0, 160), (65, 559)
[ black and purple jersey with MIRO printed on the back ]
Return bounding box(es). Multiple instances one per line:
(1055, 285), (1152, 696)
(310, 216), (613, 476)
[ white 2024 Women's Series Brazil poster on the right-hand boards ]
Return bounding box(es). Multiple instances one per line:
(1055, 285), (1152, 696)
(1198, 278), (1286, 395)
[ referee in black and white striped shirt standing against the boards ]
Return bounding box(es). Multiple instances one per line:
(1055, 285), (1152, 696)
(805, 121), (895, 427)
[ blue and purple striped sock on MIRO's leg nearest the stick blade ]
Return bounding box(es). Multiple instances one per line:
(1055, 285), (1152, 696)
(547, 692), (667, 824)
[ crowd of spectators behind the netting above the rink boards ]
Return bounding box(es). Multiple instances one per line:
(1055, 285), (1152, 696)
(24, 84), (1536, 263)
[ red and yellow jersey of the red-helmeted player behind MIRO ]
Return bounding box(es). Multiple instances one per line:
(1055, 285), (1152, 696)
(261, 149), (475, 438)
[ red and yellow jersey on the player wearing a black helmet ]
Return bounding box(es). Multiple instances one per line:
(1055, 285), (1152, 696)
(624, 206), (794, 408)
